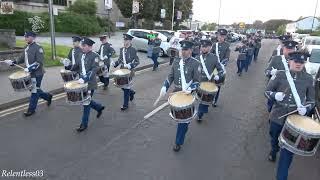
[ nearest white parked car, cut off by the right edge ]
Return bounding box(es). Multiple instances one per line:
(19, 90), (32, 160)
(305, 46), (320, 78)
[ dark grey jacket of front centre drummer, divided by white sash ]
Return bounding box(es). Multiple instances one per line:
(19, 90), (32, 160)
(166, 57), (202, 92)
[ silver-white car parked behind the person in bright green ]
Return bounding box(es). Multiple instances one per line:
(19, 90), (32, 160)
(127, 29), (169, 56)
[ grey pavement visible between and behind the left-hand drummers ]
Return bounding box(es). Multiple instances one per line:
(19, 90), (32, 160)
(0, 52), (168, 110)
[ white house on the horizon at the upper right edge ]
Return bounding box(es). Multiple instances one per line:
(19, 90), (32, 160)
(286, 16), (320, 33)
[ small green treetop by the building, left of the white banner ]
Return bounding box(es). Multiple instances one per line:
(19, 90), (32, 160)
(69, 0), (97, 15)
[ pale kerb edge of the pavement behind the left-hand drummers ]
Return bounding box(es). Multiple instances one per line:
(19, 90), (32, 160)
(0, 60), (169, 111)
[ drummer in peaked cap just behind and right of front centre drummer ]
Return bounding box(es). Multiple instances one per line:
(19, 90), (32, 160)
(197, 40), (224, 123)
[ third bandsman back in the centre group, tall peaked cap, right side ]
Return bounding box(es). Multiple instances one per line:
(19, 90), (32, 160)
(212, 29), (230, 107)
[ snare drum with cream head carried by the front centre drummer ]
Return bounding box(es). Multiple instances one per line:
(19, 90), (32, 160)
(168, 91), (196, 123)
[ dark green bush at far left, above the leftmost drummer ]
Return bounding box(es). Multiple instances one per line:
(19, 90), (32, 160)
(0, 11), (33, 36)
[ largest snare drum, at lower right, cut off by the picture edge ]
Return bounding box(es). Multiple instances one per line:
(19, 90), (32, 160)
(279, 115), (320, 156)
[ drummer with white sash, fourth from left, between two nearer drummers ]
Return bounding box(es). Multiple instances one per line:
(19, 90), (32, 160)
(98, 35), (115, 90)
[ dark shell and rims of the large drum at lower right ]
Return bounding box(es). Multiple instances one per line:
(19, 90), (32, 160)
(279, 118), (320, 156)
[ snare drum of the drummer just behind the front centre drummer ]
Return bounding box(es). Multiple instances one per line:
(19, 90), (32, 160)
(196, 82), (218, 105)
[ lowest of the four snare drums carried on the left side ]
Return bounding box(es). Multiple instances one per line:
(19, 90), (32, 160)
(64, 81), (91, 105)
